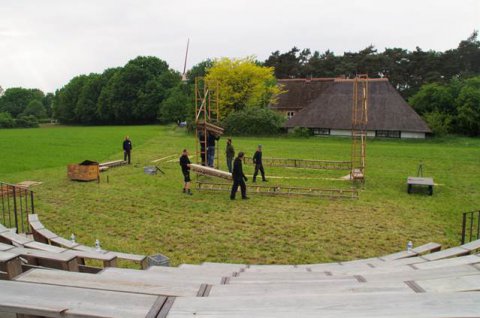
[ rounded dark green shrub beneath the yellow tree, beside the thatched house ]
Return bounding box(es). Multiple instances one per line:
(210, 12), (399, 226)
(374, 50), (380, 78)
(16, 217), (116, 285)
(222, 107), (285, 136)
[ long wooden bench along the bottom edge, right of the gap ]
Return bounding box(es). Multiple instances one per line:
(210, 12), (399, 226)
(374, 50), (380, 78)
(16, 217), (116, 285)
(168, 292), (480, 318)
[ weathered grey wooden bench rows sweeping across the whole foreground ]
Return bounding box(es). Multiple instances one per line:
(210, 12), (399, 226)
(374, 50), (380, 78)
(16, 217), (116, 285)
(0, 233), (480, 318)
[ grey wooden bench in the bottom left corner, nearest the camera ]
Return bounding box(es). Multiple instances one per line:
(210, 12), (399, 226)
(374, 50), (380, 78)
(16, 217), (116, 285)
(0, 281), (162, 318)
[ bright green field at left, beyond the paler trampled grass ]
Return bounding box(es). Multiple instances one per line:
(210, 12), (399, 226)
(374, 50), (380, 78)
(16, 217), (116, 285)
(0, 126), (158, 175)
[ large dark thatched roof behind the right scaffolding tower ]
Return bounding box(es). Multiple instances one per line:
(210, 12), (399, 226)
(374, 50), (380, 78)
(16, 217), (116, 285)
(285, 79), (431, 133)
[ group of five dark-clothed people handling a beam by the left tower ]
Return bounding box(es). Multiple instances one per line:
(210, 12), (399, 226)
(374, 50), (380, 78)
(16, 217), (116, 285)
(180, 137), (267, 200)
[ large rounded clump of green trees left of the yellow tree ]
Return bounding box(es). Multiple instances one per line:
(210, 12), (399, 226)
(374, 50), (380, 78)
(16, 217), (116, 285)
(54, 57), (181, 124)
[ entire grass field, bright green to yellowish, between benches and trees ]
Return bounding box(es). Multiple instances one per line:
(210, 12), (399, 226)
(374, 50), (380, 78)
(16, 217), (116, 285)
(0, 126), (480, 265)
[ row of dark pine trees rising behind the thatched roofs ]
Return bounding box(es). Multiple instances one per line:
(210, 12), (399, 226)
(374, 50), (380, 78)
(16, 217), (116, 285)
(264, 32), (480, 98)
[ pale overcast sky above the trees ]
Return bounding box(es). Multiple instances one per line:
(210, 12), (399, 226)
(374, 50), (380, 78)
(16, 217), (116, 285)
(0, 0), (480, 92)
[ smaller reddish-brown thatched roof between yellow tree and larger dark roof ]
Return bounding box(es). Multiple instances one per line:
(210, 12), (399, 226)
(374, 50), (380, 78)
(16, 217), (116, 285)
(270, 78), (334, 111)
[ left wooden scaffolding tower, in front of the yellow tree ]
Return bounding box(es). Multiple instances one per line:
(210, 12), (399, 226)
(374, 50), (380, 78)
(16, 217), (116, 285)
(195, 77), (223, 169)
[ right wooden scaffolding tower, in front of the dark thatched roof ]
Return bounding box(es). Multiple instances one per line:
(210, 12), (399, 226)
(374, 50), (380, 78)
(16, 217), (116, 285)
(350, 75), (368, 183)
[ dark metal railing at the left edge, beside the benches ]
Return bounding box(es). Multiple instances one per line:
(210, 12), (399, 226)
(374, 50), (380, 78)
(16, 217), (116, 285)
(0, 182), (35, 233)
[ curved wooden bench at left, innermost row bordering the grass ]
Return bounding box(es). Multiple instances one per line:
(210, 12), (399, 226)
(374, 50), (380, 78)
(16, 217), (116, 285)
(26, 214), (148, 269)
